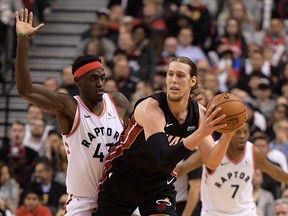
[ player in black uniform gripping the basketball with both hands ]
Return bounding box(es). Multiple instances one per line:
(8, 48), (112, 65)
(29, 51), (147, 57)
(96, 57), (243, 216)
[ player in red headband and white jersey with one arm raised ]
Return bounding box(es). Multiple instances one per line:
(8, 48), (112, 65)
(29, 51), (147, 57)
(15, 9), (130, 216)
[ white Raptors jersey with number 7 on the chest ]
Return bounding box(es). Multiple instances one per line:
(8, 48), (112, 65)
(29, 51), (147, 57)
(201, 142), (257, 216)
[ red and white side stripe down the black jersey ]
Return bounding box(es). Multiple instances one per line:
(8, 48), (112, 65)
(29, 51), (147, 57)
(99, 116), (143, 191)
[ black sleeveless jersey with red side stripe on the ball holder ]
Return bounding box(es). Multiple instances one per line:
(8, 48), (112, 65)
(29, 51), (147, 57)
(100, 92), (199, 182)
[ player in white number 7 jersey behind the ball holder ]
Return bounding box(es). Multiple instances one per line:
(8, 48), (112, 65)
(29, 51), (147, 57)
(176, 124), (288, 216)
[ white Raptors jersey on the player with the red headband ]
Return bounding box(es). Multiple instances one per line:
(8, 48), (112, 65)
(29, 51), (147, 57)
(62, 94), (123, 198)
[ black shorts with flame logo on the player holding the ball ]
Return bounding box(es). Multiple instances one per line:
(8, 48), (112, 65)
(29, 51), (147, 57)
(95, 168), (176, 216)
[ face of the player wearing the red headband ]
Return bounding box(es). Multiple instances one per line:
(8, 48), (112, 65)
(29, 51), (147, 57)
(75, 69), (105, 102)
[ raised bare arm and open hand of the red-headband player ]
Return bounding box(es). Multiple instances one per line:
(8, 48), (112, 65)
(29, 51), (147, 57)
(15, 9), (76, 115)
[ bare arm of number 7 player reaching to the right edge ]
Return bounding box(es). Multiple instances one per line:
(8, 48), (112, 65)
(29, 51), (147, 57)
(254, 146), (288, 185)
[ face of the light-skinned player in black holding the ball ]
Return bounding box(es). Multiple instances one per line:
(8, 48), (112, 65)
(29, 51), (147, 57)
(166, 62), (196, 101)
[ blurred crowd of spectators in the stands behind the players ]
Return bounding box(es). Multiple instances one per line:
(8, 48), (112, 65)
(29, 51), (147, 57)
(0, 0), (288, 216)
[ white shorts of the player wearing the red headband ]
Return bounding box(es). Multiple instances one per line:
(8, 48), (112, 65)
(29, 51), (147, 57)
(64, 194), (97, 216)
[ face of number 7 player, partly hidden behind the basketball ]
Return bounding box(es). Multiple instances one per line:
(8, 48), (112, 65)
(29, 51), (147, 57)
(229, 123), (250, 151)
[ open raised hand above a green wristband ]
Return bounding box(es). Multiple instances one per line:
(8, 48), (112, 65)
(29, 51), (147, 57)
(15, 8), (44, 37)
